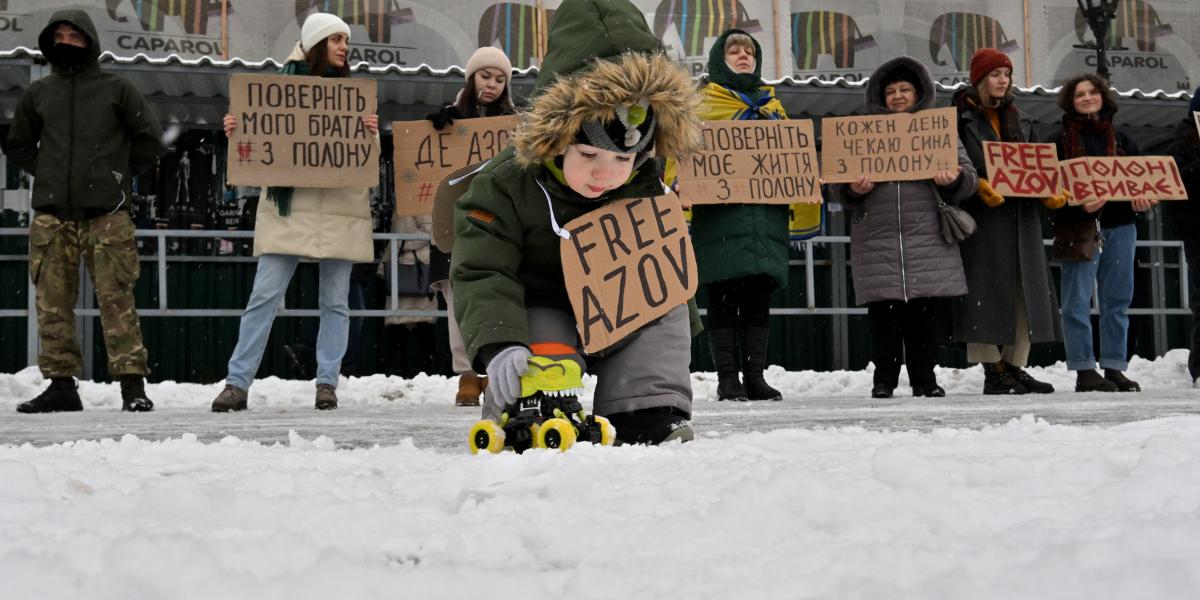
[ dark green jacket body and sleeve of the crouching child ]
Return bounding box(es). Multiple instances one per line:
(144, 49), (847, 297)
(450, 146), (662, 372)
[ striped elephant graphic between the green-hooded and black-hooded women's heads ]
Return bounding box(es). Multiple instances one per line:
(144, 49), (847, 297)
(792, 11), (878, 71)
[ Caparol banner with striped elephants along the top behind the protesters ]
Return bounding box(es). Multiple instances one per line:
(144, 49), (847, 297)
(0, 0), (1200, 90)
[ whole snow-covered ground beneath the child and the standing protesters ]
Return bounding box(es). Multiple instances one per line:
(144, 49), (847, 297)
(0, 350), (1200, 600)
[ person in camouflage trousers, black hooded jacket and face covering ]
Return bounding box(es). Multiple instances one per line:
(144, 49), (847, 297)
(8, 10), (164, 413)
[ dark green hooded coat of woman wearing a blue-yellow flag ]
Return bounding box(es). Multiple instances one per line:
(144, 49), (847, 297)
(691, 30), (788, 287)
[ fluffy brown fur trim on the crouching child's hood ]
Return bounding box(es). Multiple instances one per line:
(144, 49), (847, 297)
(514, 52), (702, 167)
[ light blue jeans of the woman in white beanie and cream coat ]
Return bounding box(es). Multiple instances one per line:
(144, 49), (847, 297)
(226, 254), (353, 390)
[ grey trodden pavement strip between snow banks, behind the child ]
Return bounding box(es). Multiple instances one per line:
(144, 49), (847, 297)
(0, 383), (1200, 451)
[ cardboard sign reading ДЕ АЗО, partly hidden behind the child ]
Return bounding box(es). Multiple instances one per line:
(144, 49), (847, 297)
(391, 116), (517, 216)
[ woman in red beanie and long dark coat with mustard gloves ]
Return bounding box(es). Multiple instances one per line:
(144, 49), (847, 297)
(954, 48), (1066, 394)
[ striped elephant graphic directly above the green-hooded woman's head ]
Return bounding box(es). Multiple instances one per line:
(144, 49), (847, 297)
(654, 0), (762, 56)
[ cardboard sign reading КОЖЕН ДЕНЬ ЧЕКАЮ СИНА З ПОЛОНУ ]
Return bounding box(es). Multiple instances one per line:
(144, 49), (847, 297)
(821, 107), (959, 184)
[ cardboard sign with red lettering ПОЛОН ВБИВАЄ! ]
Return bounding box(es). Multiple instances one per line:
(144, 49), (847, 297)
(1061, 156), (1188, 204)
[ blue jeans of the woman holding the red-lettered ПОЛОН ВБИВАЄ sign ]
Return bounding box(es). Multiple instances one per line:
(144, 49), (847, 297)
(1062, 223), (1138, 371)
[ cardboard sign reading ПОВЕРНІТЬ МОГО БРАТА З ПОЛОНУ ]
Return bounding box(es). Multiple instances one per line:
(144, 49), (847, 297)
(227, 73), (379, 187)
